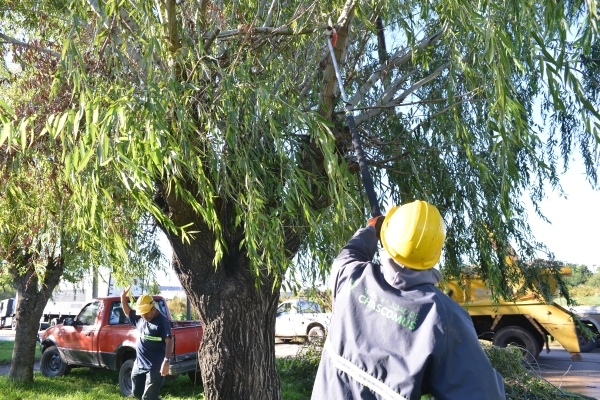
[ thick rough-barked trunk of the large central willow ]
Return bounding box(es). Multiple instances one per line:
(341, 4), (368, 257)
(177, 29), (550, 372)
(161, 191), (280, 400)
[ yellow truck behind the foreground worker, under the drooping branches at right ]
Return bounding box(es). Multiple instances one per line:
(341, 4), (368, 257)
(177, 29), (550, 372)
(443, 268), (581, 362)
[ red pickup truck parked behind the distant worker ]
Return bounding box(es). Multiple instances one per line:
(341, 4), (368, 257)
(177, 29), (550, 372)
(39, 296), (203, 397)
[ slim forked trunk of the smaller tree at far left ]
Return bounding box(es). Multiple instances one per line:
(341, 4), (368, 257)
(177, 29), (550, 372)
(9, 259), (63, 382)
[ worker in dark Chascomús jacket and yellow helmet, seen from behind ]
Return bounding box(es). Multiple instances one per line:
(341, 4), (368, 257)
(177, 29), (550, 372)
(312, 201), (505, 400)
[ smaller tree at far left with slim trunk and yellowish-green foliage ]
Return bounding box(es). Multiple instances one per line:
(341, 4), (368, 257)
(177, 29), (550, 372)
(0, 143), (162, 381)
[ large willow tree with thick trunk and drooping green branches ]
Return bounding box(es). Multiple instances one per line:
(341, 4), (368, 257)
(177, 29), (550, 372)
(0, 0), (599, 399)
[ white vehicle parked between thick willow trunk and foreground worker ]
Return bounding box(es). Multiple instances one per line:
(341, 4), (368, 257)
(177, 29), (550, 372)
(275, 298), (331, 343)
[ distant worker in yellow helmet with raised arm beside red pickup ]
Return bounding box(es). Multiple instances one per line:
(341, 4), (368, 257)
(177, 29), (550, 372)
(121, 288), (173, 400)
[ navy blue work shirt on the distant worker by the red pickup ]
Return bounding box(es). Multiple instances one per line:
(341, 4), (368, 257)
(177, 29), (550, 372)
(129, 310), (172, 369)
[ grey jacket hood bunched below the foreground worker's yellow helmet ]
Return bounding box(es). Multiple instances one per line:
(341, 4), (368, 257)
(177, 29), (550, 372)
(379, 250), (442, 290)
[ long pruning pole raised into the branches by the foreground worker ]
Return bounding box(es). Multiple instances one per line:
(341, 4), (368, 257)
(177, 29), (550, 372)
(327, 27), (381, 217)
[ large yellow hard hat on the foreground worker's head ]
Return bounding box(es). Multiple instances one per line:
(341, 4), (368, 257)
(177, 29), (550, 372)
(381, 200), (446, 269)
